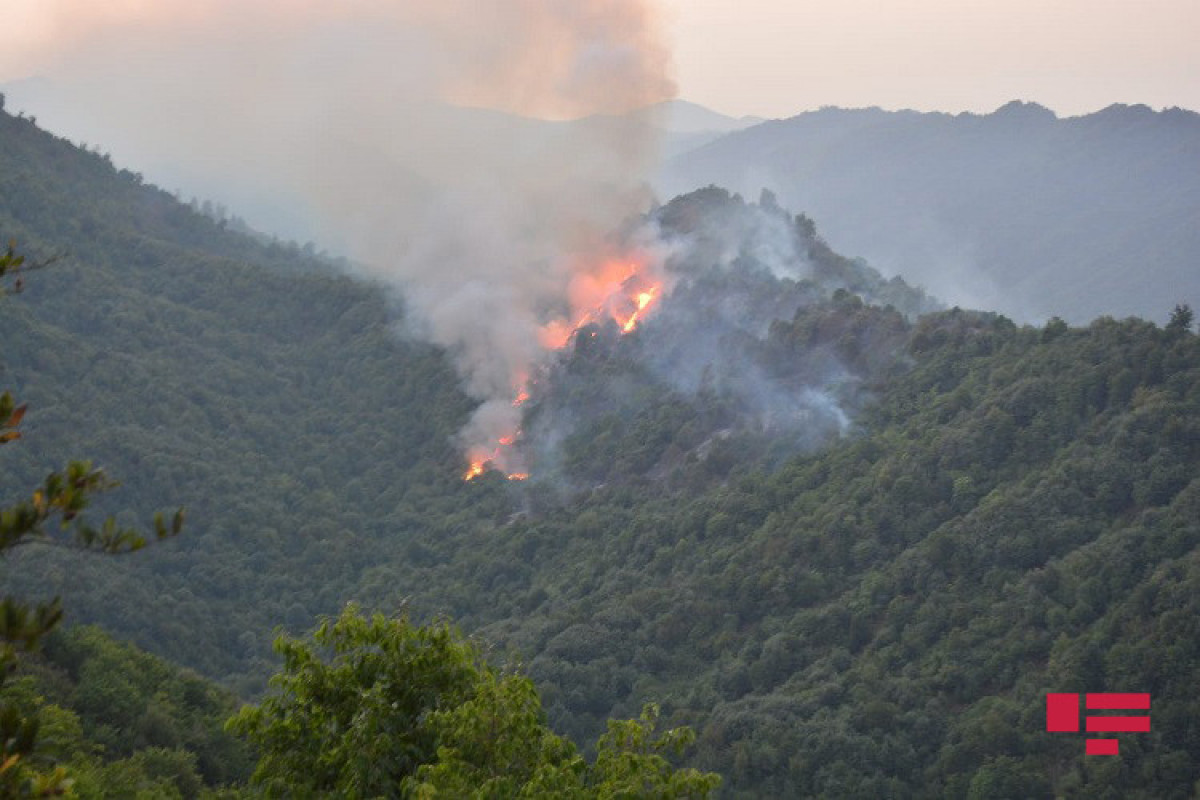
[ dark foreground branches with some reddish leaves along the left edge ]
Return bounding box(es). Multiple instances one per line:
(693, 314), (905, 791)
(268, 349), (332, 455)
(0, 242), (184, 798)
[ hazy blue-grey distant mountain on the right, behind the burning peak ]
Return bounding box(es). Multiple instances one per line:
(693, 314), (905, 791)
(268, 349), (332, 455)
(658, 102), (1200, 321)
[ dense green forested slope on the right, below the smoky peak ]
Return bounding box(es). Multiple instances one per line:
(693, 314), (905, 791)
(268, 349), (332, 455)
(451, 311), (1200, 798)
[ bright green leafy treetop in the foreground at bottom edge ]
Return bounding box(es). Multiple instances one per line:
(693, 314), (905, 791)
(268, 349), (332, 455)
(229, 604), (720, 798)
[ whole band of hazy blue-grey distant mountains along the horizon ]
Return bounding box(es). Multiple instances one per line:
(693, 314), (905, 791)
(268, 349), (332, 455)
(7, 74), (1200, 323)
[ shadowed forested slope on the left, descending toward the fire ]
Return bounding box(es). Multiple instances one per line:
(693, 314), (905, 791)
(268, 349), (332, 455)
(0, 106), (506, 691)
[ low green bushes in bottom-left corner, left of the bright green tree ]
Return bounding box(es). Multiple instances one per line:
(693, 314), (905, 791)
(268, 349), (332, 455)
(2, 626), (253, 798)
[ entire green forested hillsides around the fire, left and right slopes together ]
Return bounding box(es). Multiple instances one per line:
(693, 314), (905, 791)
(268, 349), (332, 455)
(0, 107), (1200, 799)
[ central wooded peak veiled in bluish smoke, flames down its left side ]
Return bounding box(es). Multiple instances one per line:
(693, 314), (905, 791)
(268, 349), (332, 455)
(462, 188), (934, 486)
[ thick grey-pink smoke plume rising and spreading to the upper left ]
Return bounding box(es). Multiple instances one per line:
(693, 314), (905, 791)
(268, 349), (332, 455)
(0, 0), (674, 465)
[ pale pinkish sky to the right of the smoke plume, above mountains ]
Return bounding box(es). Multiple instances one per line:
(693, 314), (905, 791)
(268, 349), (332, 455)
(665, 0), (1200, 118)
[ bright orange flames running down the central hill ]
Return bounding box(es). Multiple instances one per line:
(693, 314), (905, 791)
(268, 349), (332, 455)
(463, 259), (664, 481)
